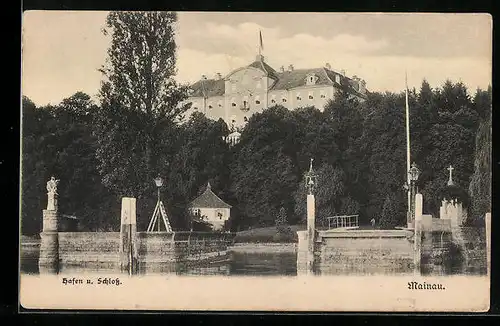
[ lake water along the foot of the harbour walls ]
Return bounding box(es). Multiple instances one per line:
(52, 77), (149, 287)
(21, 228), (487, 276)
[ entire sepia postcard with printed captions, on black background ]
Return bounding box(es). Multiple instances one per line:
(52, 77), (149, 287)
(19, 11), (492, 312)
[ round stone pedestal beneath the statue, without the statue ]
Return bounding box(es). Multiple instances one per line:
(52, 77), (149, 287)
(38, 207), (59, 274)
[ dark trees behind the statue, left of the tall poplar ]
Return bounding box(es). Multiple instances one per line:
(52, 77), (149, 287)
(22, 92), (115, 234)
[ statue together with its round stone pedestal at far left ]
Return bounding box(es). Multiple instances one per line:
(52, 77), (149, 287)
(38, 177), (59, 273)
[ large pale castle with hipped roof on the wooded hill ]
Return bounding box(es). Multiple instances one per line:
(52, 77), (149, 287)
(183, 54), (366, 128)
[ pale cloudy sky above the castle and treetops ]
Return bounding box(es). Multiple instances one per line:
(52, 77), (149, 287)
(22, 11), (492, 106)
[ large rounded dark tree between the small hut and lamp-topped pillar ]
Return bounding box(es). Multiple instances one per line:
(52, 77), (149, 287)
(231, 107), (297, 226)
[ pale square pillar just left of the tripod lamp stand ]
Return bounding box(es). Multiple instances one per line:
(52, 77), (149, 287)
(120, 197), (138, 275)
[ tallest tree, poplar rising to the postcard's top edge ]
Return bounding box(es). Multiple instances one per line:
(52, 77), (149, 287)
(97, 12), (187, 228)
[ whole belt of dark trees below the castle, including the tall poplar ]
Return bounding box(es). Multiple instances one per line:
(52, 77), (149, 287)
(21, 12), (491, 234)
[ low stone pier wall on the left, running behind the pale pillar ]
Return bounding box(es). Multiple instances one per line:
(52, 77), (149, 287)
(40, 232), (232, 272)
